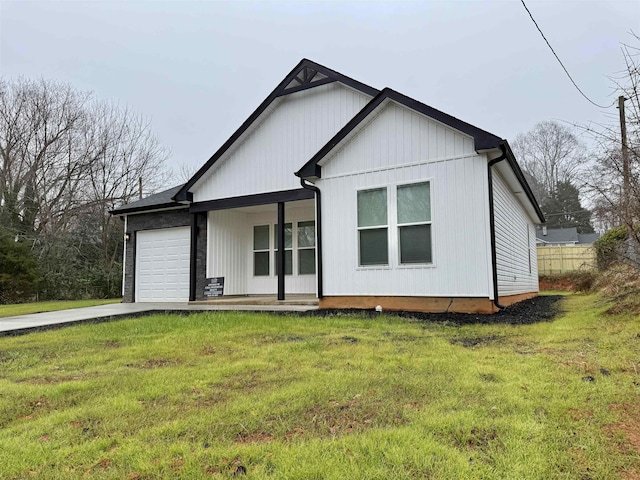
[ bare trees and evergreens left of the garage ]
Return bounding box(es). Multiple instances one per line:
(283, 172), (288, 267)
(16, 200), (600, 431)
(0, 79), (167, 303)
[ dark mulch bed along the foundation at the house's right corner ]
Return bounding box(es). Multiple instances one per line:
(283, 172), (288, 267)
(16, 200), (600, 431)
(306, 295), (563, 325)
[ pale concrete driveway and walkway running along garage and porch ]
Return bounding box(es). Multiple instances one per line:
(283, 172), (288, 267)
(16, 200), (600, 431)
(0, 303), (318, 336)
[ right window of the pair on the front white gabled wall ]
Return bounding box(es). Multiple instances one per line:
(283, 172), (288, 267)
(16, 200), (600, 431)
(397, 182), (432, 265)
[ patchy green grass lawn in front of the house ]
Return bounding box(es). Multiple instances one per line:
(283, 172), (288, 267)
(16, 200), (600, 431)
(0, 295), (640, 479)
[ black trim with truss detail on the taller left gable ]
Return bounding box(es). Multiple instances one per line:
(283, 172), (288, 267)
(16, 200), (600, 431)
(173, 58), (378, 201)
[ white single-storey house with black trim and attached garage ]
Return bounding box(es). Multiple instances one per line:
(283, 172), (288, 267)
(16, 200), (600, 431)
(112, 59), (544, 312)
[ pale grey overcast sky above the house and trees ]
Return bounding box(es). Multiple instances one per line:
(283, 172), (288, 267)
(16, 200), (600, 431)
(0, 0), (640, 186)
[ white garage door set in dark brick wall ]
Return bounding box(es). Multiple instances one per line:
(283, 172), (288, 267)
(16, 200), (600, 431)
(135, 227), (191, 302)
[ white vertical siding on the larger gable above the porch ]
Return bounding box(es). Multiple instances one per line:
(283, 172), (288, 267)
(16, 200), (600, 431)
(192, 82), (371, 202)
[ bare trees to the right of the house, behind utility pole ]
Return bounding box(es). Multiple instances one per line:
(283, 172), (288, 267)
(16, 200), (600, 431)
(513, 34), (640, 268)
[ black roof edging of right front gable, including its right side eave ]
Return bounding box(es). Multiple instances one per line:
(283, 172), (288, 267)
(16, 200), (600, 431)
(296, 88), (544, 222)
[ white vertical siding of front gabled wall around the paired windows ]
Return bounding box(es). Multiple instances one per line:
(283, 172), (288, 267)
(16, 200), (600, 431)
(316, 103), (492, 298)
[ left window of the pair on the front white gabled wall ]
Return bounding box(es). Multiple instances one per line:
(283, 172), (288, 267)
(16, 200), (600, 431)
(358, 188), (389, 266)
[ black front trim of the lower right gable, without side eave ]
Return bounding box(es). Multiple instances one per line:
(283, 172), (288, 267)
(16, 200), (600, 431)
(296, 88), (502, 178)
